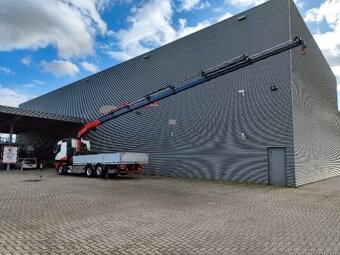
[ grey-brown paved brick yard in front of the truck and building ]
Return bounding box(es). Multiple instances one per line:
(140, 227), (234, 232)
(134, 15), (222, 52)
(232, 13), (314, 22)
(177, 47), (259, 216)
(0, 170), (340, 254)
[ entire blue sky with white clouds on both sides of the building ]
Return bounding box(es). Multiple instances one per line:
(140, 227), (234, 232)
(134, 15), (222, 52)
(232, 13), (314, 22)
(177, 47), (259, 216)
(0, 0), (340, 107)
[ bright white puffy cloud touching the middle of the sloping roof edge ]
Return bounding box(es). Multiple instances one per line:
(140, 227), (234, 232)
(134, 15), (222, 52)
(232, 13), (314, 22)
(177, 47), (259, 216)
(107, 0), (226, 61)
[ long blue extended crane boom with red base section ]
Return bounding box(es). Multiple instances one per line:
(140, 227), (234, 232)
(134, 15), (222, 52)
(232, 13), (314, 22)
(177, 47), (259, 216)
(78, 36), (306, 139)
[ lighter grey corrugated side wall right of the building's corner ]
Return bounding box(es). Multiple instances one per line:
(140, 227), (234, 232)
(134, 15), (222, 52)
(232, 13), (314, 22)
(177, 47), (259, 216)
(291, 1), (340, 185)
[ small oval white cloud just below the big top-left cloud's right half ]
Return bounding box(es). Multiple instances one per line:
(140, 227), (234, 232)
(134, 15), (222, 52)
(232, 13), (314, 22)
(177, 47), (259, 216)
(41, 60), (79, 77)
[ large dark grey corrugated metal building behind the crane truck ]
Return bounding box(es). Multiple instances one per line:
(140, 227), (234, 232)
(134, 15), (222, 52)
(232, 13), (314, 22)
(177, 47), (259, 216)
(20, 0), (340, 186)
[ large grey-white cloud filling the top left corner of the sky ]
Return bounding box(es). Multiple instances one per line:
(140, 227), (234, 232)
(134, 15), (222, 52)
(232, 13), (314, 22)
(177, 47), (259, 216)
(0, 0), (108, 59)
